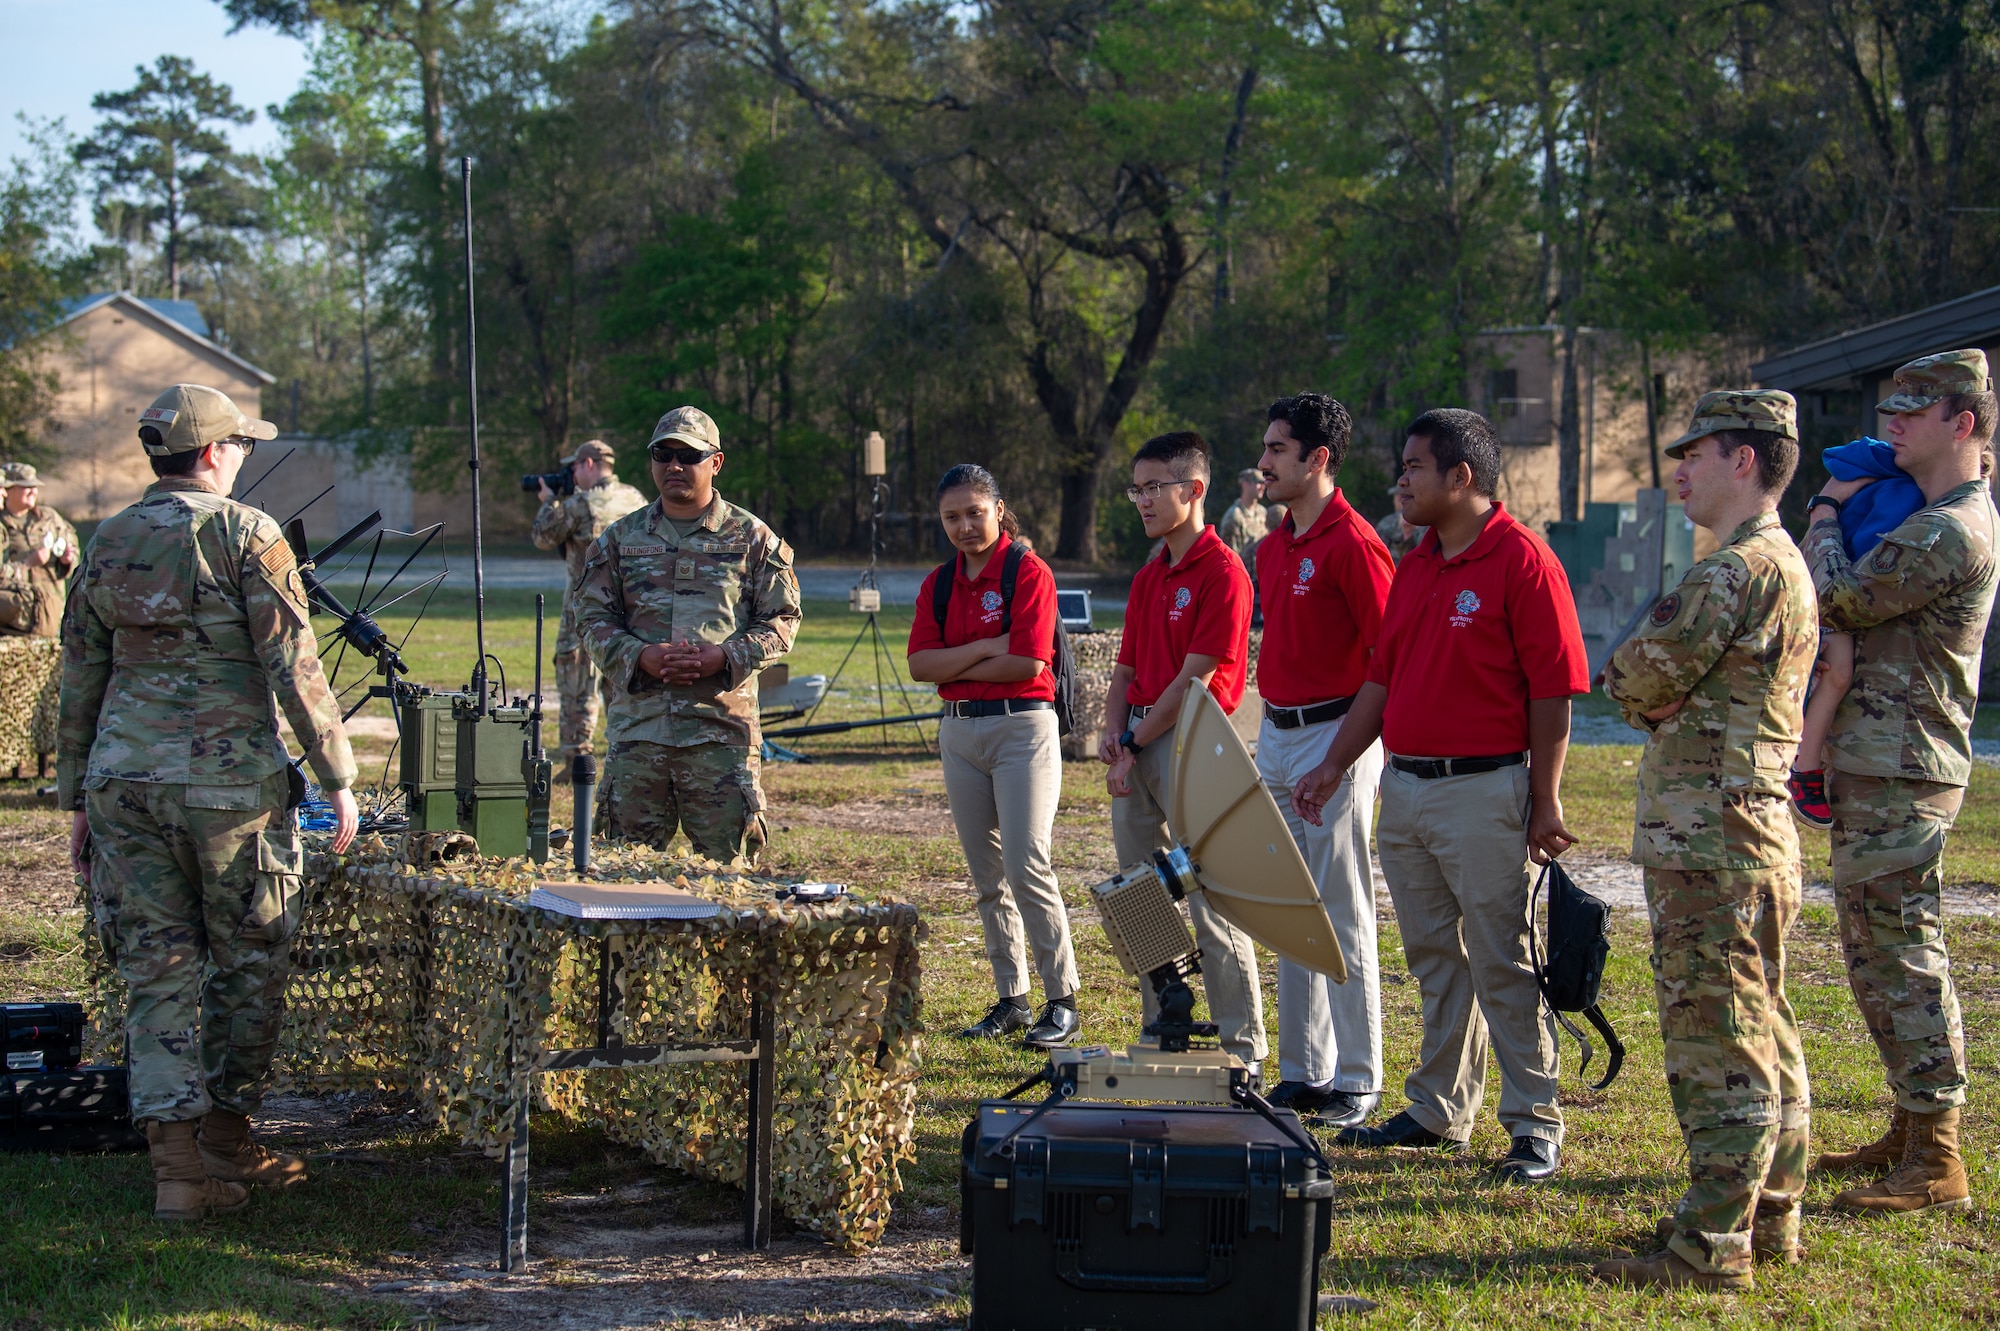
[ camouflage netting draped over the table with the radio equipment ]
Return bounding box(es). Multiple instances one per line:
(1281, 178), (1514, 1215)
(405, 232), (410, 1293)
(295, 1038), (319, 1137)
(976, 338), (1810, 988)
(88, 837), (922, 1253)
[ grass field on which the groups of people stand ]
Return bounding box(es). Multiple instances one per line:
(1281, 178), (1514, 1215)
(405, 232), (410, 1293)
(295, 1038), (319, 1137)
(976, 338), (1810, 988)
(0, 594), (2000, 1331)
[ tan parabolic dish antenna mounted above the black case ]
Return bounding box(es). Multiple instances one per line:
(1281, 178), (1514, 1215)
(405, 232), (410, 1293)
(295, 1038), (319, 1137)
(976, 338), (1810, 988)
(1166, 683), (1348, 983)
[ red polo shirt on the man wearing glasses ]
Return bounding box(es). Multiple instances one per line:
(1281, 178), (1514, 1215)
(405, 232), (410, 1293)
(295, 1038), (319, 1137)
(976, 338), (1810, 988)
(1118, 528), (1256, 711)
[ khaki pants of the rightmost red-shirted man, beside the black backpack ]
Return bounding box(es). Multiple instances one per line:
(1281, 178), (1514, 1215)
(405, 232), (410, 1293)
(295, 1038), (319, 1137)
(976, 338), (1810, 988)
(1376, 765), (1562, 1141)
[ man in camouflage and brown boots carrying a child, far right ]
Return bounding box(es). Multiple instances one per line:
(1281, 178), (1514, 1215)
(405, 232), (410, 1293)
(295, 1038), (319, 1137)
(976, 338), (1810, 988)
(1804, 350), (2000, 1211)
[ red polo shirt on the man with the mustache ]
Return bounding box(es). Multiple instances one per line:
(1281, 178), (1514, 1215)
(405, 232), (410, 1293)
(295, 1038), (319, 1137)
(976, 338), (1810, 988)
(1256, 490), (1396, 707)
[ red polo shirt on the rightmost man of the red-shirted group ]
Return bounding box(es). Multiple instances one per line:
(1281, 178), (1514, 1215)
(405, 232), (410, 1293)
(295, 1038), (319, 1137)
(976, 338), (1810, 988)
(1368, 504), (1590, 757)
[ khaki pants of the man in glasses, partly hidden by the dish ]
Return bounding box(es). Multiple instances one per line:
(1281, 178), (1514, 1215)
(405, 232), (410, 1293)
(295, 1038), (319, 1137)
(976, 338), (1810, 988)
(1112, 735), (1268, 1063)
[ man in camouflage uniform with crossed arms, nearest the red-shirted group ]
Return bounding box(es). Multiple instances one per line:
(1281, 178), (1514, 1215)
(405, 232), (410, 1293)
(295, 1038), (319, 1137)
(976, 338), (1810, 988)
(1598, 392), (1818, 1289)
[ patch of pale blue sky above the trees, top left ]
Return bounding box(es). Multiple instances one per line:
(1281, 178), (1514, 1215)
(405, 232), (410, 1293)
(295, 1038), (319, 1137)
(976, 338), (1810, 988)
(0, 0), (306, 160)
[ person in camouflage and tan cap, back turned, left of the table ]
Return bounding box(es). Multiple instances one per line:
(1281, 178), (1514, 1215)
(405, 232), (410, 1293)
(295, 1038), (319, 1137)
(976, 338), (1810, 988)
(56, 384), (356, 1219)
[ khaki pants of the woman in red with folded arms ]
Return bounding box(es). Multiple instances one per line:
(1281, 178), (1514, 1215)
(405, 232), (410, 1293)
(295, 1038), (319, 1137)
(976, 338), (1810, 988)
(938, 711), (1076, 999)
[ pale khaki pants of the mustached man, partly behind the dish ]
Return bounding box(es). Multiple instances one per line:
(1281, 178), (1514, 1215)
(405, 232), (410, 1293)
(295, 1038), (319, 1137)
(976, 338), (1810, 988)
(1256, 719), (1382, 1091)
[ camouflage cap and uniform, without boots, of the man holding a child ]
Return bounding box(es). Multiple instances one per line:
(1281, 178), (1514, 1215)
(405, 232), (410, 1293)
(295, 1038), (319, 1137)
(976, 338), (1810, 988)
(1804, 352), (2000, 1113)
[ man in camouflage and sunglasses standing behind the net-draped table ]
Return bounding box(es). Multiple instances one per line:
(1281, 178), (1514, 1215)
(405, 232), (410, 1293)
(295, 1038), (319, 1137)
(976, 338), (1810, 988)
(576, 408), (798, 861)
